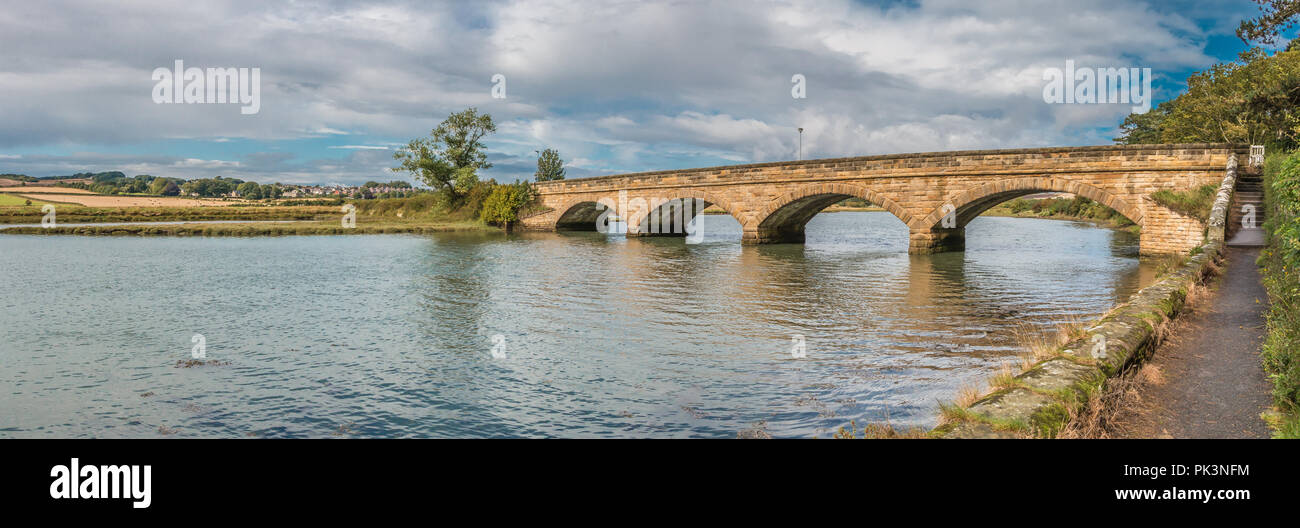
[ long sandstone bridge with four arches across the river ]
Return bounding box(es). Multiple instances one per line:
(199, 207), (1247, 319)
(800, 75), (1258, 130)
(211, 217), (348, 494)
(521, 144), (1248, 254)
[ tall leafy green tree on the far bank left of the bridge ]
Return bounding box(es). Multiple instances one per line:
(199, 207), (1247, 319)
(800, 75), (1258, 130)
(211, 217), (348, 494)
(393, 108), (497, 198)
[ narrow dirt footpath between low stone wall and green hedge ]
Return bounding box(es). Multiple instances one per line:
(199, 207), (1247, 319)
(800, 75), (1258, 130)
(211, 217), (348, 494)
(1123, 247), (1271, 438)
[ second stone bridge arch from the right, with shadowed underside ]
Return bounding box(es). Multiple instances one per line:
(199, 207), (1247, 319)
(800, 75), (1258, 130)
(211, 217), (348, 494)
(745, 183), (913, 243)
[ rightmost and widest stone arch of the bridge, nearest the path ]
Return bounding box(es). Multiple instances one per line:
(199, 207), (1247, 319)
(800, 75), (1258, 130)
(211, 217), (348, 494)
(907, 177), (1144, 252)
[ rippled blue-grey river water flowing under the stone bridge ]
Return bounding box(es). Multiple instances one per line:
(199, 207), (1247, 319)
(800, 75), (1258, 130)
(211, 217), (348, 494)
(0, 212), (1153, 437)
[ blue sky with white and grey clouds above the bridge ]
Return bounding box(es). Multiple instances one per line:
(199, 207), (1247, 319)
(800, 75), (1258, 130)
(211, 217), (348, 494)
(0, 0), (1279, 183)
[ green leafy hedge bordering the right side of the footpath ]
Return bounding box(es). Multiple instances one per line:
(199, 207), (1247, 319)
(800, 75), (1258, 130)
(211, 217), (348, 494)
(1258, 152), (1300, 438)
